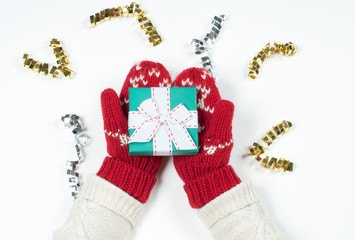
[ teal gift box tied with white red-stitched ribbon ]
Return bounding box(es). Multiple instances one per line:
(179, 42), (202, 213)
(128, 87), (198, 156)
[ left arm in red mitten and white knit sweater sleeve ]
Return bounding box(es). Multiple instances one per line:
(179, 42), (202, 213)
(54, 61), (171, 240)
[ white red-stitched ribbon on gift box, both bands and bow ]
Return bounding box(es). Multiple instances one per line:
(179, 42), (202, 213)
(128, 88), (197, 155)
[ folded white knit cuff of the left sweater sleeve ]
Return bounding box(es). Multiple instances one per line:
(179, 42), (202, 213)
(78, 174), (143, 226)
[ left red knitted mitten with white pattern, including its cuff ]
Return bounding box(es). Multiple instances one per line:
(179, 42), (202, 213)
(97, 61), (171, 203)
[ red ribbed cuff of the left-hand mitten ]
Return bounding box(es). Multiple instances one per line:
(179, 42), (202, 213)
(97, 157), (156, 203)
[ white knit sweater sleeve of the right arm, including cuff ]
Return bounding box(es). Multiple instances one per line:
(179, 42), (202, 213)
(197, 182), (284, 240)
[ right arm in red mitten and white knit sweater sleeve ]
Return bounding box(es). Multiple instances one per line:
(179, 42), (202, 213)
(173, 68), (282, 240)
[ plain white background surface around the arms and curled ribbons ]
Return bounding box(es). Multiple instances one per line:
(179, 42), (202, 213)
(0, 0), (355, 240)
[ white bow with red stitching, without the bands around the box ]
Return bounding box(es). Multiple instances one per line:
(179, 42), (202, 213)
(129, 98), (197, 150)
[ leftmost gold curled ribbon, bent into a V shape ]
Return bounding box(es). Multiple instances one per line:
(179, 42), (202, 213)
(23, 38), (74, 78)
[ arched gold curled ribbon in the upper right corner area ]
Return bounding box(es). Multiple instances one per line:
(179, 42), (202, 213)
(248, 42), (297, 79)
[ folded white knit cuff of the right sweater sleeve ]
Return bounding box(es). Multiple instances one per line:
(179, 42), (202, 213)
(197, 182), (258, 228)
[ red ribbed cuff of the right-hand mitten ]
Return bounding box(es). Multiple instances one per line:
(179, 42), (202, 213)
(184, 165), (241, 208)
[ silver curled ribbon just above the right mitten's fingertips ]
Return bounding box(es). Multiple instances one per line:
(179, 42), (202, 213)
(191, 14), (225, 74)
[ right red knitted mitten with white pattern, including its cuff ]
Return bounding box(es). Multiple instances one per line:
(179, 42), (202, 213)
(173, 68), (241, 208)
